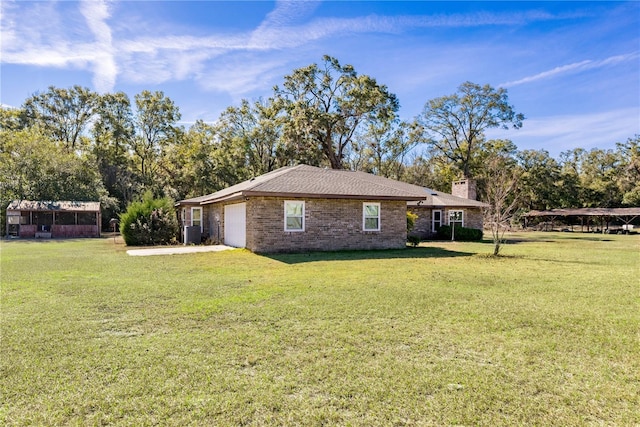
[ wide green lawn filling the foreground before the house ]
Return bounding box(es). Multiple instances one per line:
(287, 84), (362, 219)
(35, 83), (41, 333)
(0, 233), (640, 426)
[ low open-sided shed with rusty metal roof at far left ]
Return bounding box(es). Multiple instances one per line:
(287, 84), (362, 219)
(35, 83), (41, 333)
(7, 200), (100, 239)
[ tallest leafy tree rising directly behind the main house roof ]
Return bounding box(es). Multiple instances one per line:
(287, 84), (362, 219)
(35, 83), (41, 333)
(274, 55), (399, 169)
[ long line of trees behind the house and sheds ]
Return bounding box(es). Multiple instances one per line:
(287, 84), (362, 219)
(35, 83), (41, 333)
(0, 56), (640, 232)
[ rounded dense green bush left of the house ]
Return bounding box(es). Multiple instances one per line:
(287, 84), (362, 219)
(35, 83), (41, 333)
(120, 193), (178, 246)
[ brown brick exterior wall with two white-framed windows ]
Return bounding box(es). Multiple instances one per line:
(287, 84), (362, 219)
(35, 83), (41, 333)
(218, 197), (407, 253)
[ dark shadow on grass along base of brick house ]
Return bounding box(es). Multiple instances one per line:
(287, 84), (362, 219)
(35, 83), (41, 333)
(260, 247), (475, 264)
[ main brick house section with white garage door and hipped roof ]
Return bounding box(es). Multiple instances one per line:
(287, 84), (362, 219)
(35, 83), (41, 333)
(177, 165), (425, 253)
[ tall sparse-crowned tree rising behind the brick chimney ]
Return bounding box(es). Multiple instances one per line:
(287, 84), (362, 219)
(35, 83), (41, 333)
(418, 82), (524, 178)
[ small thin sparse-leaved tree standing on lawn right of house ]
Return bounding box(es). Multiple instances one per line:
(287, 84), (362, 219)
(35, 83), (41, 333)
(484, 156), (520, 256)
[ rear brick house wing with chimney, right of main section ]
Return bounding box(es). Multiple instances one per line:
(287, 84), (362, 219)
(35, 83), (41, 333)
(408, 179), (489, 239)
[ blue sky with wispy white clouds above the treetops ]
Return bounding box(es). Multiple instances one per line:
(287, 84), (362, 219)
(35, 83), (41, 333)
(0, 0), (640, 156)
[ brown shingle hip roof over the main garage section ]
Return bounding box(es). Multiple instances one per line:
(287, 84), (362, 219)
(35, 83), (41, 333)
(178, 165), (425, 204)
